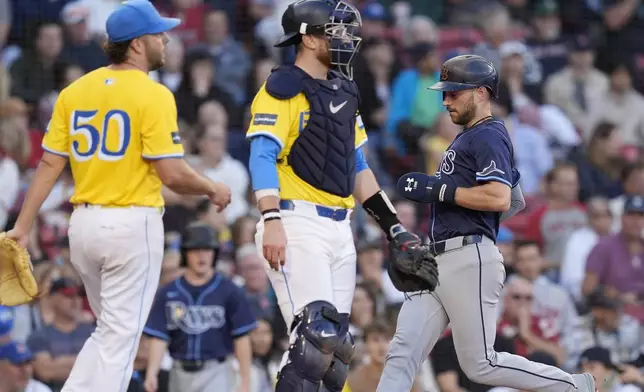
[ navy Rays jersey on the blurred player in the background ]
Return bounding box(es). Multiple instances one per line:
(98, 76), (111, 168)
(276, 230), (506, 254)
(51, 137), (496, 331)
(143, 274), (257, 360)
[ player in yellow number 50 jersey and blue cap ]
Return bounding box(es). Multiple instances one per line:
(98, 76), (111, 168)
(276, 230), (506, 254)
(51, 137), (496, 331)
(7, 0), (230, 392)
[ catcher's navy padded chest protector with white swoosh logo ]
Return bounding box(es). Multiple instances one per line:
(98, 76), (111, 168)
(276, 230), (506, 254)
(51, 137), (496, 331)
(267, 66), (359, 197)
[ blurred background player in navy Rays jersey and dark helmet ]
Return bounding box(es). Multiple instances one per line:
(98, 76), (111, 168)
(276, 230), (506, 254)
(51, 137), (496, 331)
(143, 224), (257, 392)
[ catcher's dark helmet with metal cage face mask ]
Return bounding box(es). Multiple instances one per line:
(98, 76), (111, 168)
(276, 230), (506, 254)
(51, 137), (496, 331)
(275, 0), (362, 79)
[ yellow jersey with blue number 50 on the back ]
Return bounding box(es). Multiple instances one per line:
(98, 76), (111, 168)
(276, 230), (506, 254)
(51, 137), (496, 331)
(43, 68), (183, 207)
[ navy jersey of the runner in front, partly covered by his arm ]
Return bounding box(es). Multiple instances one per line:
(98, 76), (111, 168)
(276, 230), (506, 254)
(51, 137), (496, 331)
(429, 119), (518, 242)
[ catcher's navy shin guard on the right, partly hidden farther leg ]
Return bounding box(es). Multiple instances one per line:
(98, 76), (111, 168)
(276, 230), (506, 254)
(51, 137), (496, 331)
(322, 314), (355, 392)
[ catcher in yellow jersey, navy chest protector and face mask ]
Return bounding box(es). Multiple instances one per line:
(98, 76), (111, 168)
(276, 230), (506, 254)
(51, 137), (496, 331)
(247, 0), (420, 392)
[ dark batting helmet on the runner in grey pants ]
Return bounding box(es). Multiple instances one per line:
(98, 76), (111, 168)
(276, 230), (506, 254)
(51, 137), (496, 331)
(429, 54), (499, 98)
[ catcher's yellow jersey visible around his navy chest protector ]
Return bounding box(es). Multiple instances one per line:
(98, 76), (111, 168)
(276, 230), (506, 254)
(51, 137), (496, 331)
(246, 85), (367, 208)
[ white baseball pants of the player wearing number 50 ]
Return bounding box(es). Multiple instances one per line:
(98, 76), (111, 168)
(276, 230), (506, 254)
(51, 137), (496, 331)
(62, 206), (164, 392)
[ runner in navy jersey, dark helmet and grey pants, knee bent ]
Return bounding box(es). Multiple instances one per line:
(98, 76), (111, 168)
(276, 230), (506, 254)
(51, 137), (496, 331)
(377, 55), (595, 392)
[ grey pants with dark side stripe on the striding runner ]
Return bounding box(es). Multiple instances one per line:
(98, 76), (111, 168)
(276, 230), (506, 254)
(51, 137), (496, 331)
(376, 237), (577, 392)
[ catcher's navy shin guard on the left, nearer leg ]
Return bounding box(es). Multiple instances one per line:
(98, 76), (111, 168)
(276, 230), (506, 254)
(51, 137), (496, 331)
(275, 301), (342, 392)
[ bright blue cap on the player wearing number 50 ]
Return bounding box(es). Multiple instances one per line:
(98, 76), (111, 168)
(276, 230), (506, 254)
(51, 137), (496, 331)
(105, 0), (181, 42)
